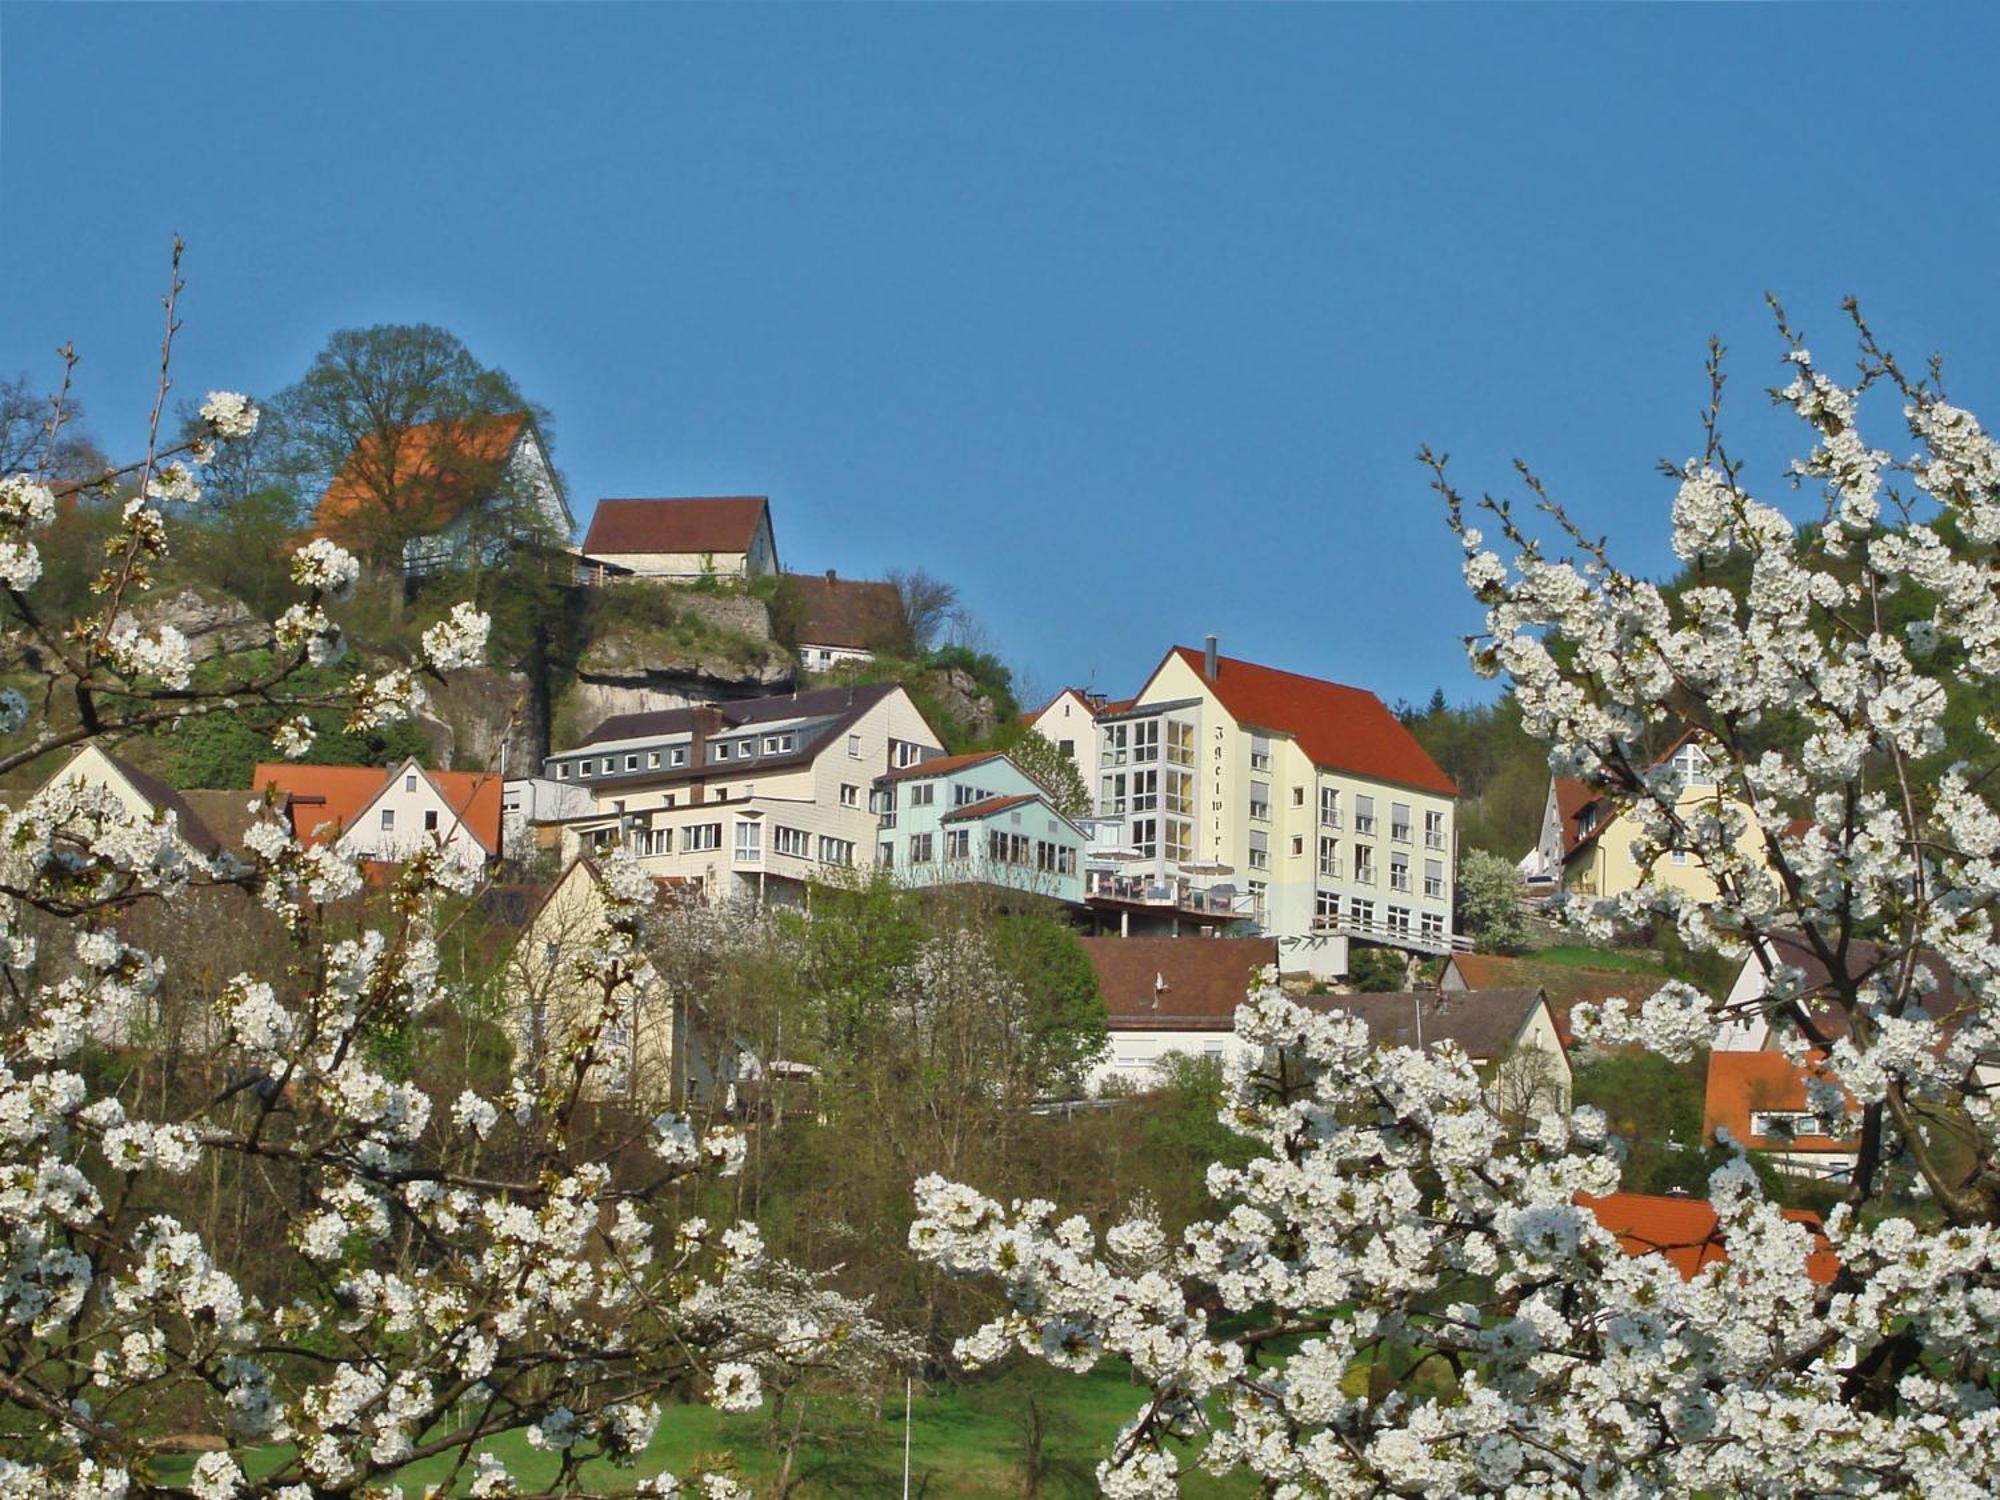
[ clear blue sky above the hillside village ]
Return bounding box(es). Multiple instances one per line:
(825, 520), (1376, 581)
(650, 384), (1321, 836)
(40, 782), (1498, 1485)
(0, 4), (2000, 700)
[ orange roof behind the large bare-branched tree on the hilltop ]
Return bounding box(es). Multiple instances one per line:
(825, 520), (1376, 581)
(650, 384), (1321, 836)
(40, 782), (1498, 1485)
(312, 412), (528, 544)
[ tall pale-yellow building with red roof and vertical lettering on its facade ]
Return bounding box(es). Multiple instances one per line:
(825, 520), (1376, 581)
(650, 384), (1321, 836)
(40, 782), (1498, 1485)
(1072, 636), (1456, 978)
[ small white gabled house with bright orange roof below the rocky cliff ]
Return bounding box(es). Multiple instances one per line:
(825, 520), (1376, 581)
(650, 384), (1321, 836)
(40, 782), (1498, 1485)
(252, 760), (502, 872)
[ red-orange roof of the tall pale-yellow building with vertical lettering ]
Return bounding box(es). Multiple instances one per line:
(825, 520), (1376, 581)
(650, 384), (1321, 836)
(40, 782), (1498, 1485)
(1160, 646), (1458, 796)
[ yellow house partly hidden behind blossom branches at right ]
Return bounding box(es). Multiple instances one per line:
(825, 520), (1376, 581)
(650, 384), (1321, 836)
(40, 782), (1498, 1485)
(1518, 732), (1766, 900)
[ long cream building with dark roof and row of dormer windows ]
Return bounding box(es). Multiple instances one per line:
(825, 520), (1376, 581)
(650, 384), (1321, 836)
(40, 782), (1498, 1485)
(544, 684), (944, 902)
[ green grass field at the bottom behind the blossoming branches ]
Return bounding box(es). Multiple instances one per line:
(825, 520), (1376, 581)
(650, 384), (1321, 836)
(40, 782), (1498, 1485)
(160, 1366), (1256, 1500)
